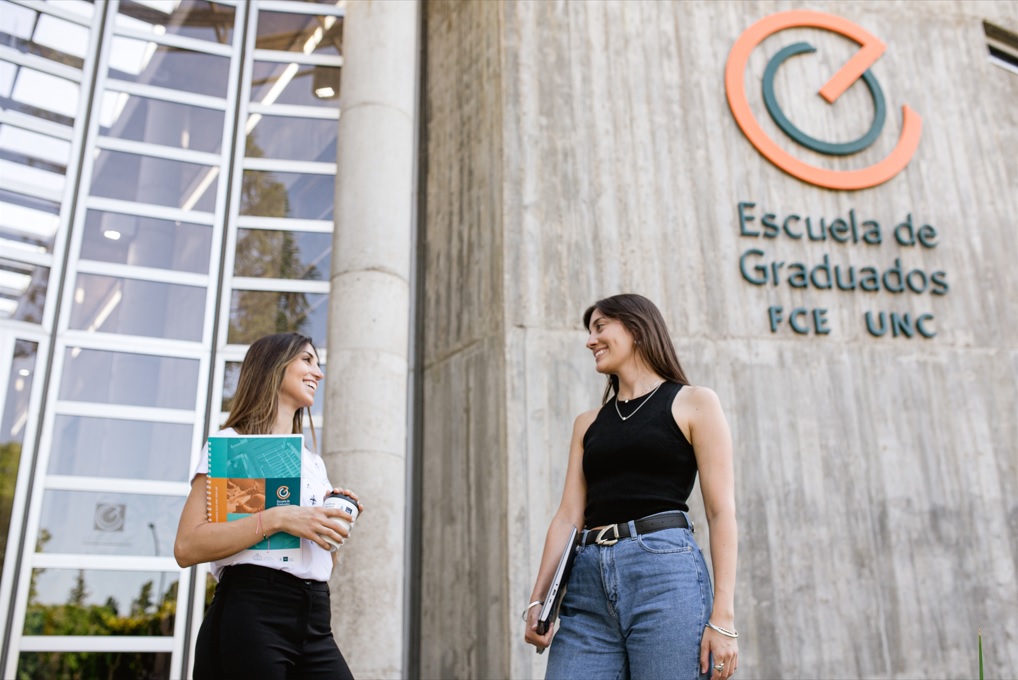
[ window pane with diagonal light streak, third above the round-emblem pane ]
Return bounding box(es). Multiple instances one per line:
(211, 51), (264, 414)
(70, 274), (206, 341)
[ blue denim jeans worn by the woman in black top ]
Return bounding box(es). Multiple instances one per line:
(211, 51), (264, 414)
(545, 515), (714, 680)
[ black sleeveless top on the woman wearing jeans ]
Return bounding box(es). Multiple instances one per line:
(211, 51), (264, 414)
(583, 383), (696, 528)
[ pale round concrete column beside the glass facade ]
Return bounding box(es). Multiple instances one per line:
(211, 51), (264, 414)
(323, 0), (418, 678)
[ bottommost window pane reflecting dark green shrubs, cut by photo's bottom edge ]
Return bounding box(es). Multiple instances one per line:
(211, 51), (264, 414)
(17, 651), (170, 680)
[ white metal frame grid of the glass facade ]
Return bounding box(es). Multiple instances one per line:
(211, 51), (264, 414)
(0, 0), (345, 677)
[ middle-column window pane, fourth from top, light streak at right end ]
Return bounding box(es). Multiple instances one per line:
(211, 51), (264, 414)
(92, 151), (219, 213)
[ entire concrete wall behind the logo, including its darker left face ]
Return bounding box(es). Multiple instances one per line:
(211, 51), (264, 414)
(421, 0), (1018, 678)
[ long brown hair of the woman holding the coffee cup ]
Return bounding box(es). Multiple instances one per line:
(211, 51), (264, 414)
(223, 333), (318, 450)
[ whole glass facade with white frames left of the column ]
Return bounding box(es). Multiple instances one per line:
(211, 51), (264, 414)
(0, 0), (344, 678)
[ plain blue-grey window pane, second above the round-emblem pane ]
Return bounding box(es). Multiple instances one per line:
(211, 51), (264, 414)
(59, 347), (199, 409)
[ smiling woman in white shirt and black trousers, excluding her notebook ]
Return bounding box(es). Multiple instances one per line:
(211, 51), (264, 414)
(173, 333), (363, 680)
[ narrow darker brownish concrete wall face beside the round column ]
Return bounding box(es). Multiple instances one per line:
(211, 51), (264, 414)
(419, 2), (512, 678)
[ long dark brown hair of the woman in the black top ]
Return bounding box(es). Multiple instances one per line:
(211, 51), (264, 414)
(583, 293), (689, 404)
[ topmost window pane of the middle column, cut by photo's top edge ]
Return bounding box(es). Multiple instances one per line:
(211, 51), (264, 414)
(117, 0), (236, 45)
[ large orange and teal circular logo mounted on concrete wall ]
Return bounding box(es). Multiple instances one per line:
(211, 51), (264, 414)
(725, 10), (922, 190)
